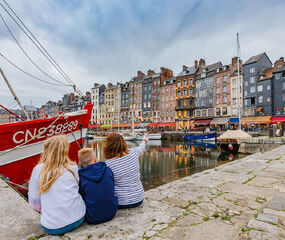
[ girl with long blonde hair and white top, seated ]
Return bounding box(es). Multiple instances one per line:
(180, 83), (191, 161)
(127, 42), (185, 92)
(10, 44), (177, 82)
(28, 135), (85, 234)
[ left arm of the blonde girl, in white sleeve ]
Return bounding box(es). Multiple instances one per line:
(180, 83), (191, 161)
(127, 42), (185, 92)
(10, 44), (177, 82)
(28, 167), (41, 212)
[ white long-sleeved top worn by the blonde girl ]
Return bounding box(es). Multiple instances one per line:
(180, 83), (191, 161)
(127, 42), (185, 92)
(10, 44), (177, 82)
(28, 164), (85, 229)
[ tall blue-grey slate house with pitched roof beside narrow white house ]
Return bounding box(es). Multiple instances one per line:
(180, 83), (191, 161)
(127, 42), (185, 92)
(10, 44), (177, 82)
(242, 53), (272, 116)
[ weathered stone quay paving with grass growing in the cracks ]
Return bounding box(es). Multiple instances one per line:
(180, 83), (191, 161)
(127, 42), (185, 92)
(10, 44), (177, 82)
(2, 143), (285, 240)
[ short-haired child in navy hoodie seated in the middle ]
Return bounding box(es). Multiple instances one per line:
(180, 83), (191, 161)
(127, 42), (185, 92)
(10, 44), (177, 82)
(78, 148), (118, 224)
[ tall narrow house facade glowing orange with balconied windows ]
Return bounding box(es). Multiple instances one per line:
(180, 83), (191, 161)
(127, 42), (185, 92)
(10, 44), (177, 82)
(175, 61), (198, 129)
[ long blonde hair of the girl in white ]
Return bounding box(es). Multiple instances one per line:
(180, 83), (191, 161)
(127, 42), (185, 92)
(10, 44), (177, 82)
(39, 135), (78, 194)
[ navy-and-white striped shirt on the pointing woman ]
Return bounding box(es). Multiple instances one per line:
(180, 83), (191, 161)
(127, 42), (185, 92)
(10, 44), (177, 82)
(106, 143), (145, 205)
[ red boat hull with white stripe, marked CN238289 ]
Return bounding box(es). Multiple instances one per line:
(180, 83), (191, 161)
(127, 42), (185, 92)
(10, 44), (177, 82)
(0, 103), (93, 185)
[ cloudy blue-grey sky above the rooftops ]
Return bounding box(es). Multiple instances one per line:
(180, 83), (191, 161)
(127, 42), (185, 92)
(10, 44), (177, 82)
(0, 0), (285, 107)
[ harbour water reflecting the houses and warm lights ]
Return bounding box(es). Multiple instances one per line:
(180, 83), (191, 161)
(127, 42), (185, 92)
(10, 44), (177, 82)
(87, 140), (245, 190)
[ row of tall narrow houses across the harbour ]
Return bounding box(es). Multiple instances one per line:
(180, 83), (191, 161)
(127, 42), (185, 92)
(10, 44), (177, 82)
(91, 53), (285, 129)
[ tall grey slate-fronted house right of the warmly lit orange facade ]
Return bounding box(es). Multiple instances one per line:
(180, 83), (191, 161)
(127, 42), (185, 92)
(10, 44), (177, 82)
(195, 59), (222, 119)
